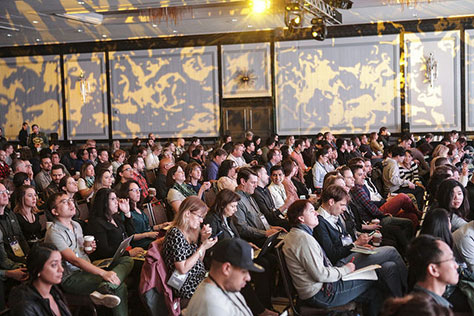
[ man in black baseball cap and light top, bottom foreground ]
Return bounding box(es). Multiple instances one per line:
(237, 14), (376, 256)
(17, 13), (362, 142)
(183, 238), (264, 316)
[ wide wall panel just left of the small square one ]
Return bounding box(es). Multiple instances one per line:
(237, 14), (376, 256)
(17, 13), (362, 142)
(110, 46), (220, 138)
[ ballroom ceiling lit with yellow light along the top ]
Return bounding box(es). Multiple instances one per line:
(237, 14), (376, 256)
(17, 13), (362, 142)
(0, 0), (474, 47)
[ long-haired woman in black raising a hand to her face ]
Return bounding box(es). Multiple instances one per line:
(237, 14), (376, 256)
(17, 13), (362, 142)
(87, 188), (144, 260)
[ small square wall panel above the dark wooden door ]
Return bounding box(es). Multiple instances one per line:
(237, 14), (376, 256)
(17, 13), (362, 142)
(222, 43), (272, 98)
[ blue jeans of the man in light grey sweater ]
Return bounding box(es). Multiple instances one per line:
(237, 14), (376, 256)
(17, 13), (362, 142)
(303, 280), (385, 316)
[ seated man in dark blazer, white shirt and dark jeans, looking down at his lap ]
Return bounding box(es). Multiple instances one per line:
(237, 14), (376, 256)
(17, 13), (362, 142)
(313, 185), (407, 296)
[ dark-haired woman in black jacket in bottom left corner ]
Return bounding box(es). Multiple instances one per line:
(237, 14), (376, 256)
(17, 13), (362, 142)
(9, 244), (72, 316)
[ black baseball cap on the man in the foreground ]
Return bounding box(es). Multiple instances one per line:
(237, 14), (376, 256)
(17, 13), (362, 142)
(212, 238), (265, 272)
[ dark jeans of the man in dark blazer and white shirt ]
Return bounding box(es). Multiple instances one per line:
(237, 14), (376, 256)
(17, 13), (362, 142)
(337, 246), (408, 297)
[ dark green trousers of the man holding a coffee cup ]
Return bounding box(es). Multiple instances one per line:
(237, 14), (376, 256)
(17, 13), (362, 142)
(61, 256), (133, 316)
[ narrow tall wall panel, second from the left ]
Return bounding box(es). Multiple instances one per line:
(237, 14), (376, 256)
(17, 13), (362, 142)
(64, 53), (109, 139)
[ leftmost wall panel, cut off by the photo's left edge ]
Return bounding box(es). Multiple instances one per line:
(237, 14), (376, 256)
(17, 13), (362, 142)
(0, 56), (63, 140)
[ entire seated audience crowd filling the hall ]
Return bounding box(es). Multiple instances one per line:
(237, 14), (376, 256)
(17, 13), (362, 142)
(0, 122), (474, 316)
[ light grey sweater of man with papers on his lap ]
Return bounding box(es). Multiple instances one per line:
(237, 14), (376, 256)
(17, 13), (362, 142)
(282, 227), (350, 300)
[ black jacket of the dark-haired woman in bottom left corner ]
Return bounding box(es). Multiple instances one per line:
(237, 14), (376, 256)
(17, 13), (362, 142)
(8, 282), (71, 316)
